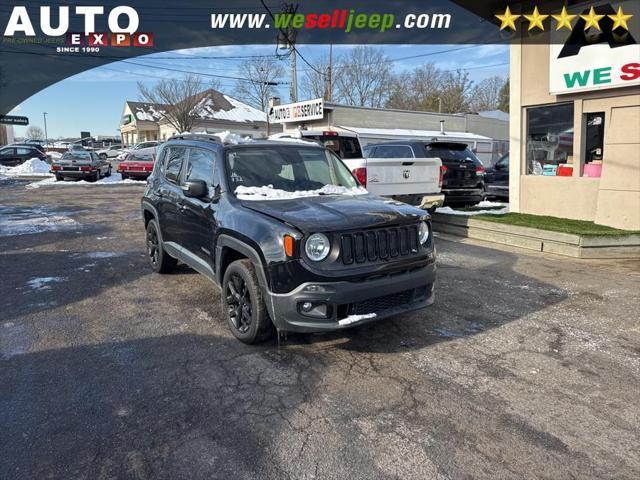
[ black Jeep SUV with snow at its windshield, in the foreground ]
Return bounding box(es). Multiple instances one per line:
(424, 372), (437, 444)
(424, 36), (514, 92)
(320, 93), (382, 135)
(142, 135), (436, 343)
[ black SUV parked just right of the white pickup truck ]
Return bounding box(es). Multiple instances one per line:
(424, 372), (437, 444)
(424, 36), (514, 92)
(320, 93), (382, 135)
(425, 142), (485, 206)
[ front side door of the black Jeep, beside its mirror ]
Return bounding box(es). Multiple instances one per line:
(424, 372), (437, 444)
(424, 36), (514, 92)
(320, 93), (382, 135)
(180, 147), (217, 268)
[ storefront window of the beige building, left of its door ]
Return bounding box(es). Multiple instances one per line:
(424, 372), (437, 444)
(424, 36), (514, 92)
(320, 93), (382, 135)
(527, 103), (573, 176)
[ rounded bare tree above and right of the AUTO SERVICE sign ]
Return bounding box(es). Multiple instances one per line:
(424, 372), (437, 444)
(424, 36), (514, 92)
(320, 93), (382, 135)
(333, 46), (393, 107)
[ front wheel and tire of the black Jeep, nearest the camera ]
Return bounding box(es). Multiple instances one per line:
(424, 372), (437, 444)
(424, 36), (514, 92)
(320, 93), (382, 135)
(222, 259), (274, 344)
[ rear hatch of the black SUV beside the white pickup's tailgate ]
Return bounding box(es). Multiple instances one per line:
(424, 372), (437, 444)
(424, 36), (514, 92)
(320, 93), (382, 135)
(425, 142), (484, 190)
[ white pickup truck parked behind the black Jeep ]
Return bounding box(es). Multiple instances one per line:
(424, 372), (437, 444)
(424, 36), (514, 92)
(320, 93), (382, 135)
(269, 129), (444, 210)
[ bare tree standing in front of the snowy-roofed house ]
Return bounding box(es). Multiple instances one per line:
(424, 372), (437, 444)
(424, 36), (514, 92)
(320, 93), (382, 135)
(138, 74), (205, 132)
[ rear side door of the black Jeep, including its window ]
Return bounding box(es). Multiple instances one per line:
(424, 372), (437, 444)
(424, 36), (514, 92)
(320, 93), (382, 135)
(157, 146), (187, 243)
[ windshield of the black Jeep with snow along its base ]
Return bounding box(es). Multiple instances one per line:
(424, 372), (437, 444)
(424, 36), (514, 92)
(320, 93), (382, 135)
(226, 146), (358, 196)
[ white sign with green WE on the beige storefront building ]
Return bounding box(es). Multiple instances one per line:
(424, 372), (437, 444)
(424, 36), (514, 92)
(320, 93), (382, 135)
(549, 2), (640, 95)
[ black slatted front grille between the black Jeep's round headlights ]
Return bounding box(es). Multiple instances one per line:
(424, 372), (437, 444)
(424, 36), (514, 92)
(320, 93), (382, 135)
(340, 225), (418, 265)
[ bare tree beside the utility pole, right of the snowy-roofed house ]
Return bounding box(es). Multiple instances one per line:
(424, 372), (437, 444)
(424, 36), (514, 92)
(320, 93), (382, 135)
(234, 57), (284, 112)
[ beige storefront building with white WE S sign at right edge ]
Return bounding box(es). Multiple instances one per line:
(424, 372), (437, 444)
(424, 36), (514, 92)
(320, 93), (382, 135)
(509, 2), (640, 230)
